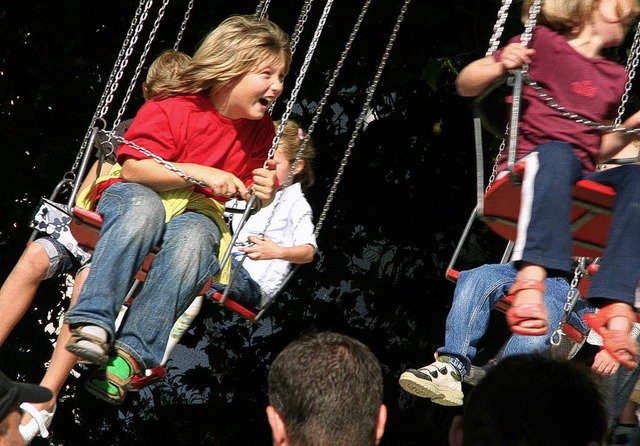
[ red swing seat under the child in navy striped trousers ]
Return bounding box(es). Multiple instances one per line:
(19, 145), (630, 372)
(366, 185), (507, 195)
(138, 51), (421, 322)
(480, 161), (616, 258)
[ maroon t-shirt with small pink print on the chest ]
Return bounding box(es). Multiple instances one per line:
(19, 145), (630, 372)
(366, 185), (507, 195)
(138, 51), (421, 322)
(494, 26), (627, 173)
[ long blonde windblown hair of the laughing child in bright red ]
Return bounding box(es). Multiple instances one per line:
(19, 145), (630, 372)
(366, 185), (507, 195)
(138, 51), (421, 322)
(155, 15), (291, 96)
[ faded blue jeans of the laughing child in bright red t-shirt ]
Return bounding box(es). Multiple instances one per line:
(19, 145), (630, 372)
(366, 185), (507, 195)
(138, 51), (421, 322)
(65, 182), (220, 368)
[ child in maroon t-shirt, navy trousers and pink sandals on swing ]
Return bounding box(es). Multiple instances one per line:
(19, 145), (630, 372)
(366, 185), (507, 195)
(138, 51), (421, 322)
(456, 0), (640, 369)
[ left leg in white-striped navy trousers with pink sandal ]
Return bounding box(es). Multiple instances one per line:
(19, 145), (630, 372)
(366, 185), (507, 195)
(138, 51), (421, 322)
(507, 141), (582, 335)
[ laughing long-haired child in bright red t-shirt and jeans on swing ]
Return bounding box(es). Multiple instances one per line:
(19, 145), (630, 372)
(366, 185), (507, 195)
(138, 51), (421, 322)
(65, 16), (291, 403)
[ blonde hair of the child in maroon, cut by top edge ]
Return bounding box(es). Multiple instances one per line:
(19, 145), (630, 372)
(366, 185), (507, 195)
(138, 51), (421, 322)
(522, 0), (640, 33)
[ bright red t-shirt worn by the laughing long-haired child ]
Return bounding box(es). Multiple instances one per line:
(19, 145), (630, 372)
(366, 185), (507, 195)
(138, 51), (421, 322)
(117, 93), (275, 201)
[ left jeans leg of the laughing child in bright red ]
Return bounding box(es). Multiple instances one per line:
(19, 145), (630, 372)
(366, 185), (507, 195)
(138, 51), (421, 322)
(65, 182), (165, 339)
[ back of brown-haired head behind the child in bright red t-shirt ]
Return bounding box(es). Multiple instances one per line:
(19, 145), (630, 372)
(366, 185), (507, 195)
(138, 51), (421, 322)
(142, 50), (191, 100)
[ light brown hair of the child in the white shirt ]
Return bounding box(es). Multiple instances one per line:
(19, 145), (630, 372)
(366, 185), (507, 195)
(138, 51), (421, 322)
(274, 119), (316, 190)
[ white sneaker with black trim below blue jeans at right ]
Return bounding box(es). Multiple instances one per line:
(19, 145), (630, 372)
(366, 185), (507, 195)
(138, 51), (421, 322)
(398, 356), (464, 406)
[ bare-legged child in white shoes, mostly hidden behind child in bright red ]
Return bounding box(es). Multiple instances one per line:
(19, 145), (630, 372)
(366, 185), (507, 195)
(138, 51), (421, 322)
(0, 46), (191, 444)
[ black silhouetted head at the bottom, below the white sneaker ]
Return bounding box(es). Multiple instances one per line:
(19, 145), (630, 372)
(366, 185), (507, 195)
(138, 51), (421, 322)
(462, 354), (607, 446)
